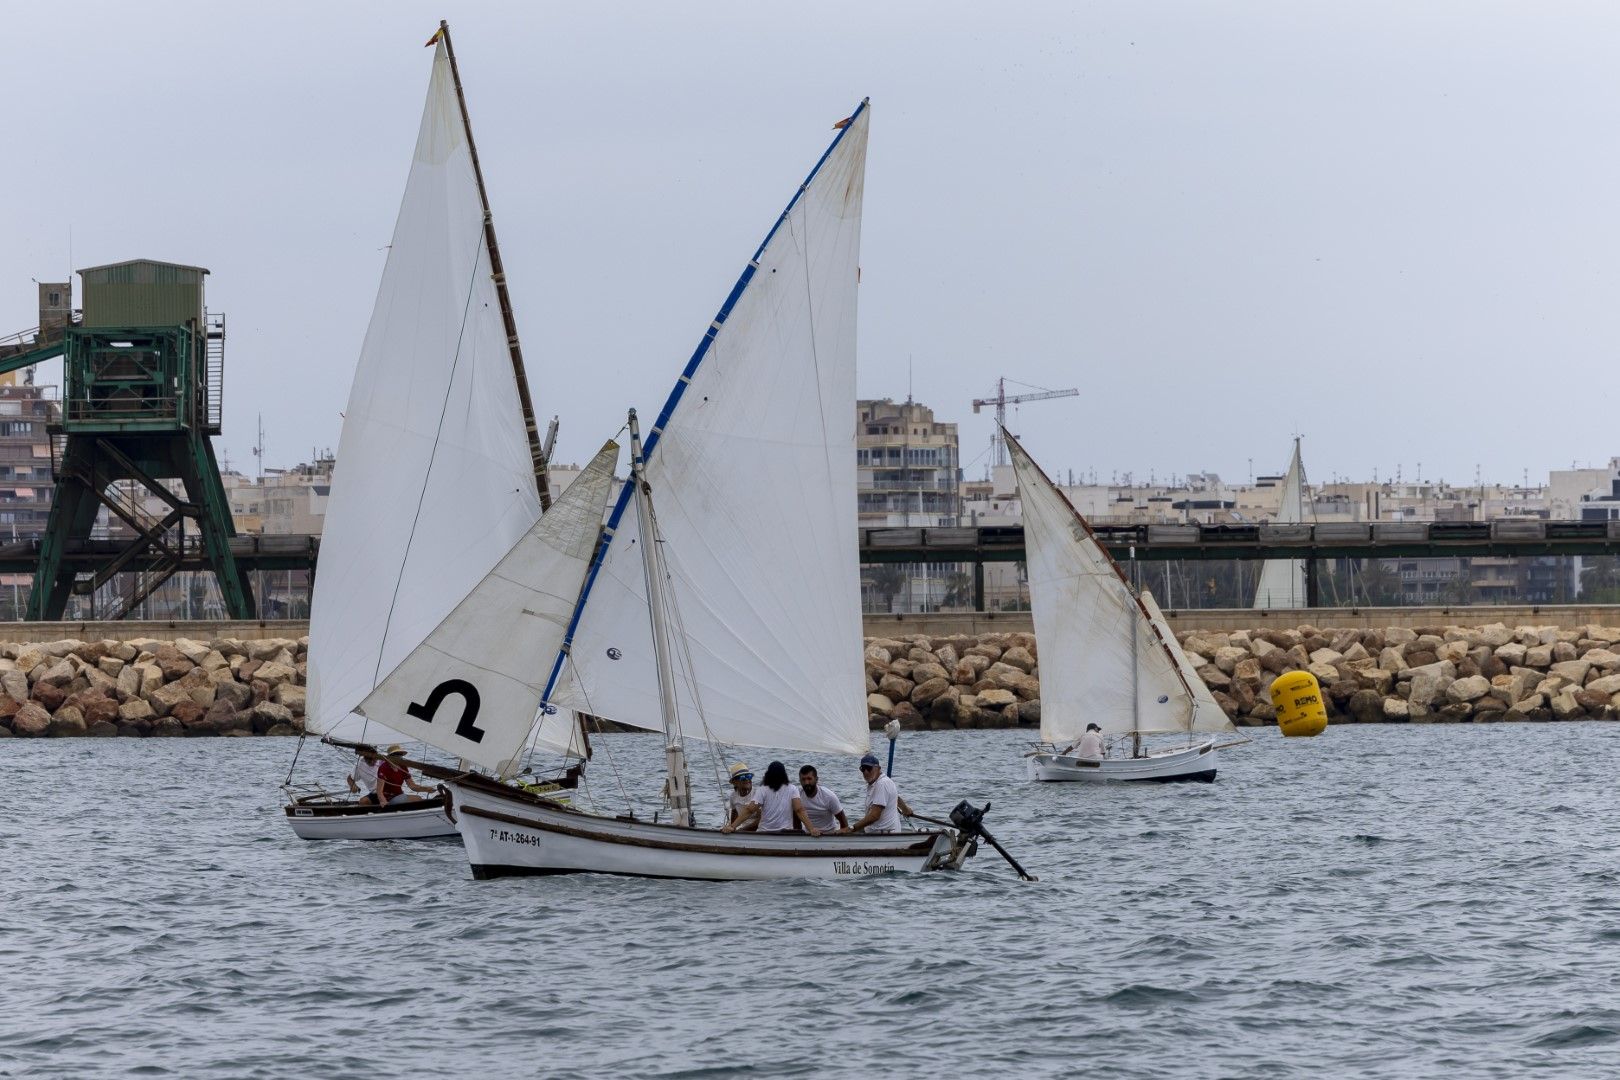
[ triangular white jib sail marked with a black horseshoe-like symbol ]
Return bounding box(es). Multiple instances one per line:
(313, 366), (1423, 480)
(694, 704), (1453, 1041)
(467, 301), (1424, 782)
(358, 442), (619, 776)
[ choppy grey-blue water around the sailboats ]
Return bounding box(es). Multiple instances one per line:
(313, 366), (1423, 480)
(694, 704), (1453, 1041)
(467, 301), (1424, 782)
(0, 724), (1620, 1077)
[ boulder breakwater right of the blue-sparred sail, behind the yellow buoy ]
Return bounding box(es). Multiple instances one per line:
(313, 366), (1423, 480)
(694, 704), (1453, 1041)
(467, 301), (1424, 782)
(865, 623), (1620, 729)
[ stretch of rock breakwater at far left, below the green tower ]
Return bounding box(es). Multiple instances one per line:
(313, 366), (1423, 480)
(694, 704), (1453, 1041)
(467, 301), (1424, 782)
(0, 638), (309, 738)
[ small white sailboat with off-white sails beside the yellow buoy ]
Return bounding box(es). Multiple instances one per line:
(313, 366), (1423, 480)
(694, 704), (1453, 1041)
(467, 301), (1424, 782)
(1003, 431), (1233, 782)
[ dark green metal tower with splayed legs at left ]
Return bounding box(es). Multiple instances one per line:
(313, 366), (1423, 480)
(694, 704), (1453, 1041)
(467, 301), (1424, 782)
(12, 259), (254, 620)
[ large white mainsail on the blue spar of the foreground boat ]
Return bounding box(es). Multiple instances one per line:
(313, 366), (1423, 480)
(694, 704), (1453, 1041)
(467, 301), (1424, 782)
(552, 105), (870, 753)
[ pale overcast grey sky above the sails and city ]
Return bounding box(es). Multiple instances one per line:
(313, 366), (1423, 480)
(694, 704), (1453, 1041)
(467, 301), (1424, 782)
(9, 0), (1620, 483)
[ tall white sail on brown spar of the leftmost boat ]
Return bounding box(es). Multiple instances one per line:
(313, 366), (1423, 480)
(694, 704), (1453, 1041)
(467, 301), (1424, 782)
(306, 42), (539, 740)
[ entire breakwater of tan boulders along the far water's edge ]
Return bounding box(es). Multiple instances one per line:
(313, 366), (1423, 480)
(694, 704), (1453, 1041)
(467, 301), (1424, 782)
(12, 623), (1620, 738)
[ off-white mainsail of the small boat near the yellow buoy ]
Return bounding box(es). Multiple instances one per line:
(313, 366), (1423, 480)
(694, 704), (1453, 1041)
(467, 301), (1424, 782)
(1006, 436), (1192, 745)
